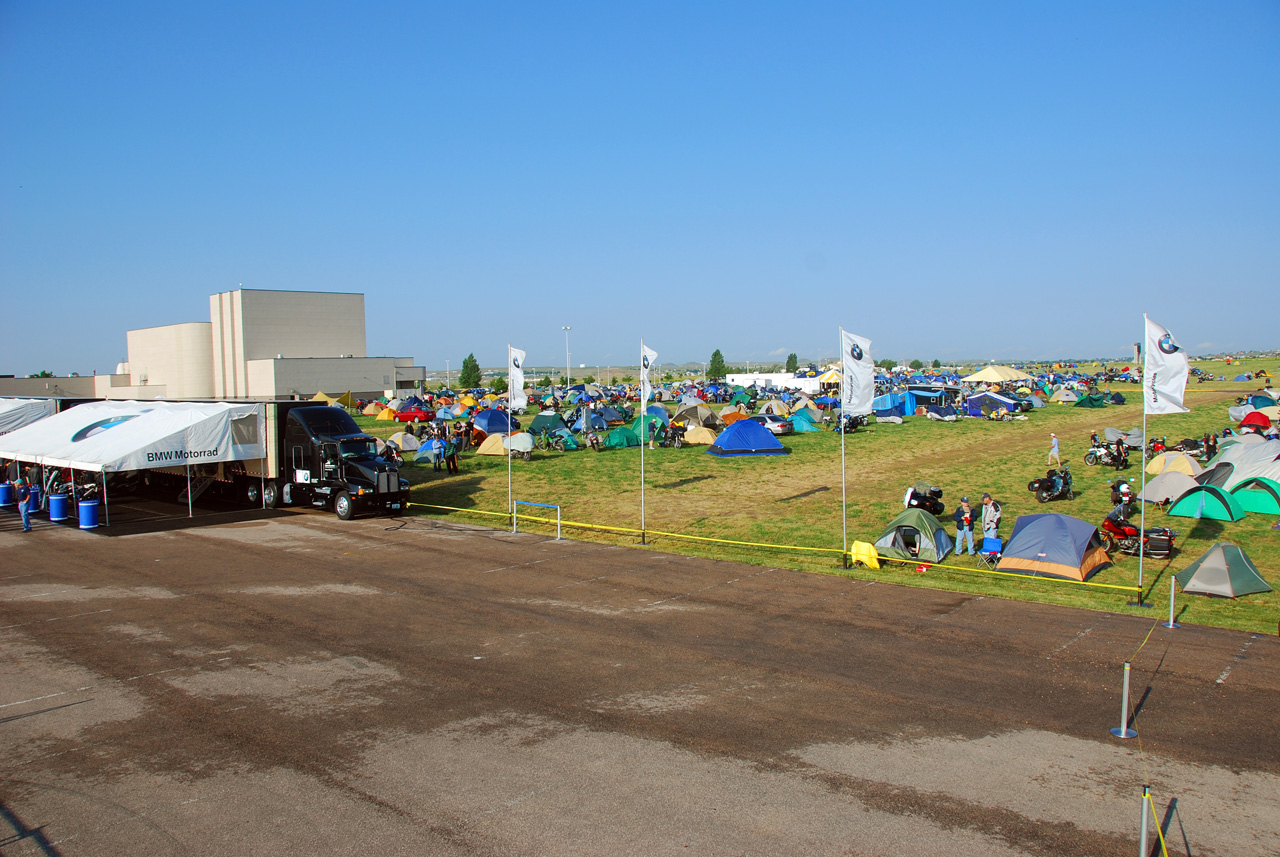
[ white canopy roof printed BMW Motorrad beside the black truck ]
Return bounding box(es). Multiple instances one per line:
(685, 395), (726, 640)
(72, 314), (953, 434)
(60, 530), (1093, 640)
(0, 402), (266, 472)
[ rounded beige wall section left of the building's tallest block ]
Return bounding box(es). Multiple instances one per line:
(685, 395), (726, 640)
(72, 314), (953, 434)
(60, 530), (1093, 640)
(124, 321), (214, 399)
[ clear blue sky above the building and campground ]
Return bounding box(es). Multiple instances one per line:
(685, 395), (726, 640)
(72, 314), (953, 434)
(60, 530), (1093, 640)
(0, 0), (1280, 373)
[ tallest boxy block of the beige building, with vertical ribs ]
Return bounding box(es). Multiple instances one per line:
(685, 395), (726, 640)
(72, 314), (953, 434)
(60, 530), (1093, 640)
(209, 289), (366, 398)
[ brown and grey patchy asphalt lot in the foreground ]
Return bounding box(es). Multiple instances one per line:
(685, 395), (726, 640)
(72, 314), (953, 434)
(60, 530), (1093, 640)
(0, 513), (1280, 856)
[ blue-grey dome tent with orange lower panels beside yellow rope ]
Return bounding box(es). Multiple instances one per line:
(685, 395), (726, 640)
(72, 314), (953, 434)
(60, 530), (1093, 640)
(996, 512), (1111, 582)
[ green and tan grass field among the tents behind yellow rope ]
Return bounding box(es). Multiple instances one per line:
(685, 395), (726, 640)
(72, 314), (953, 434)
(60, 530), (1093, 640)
(360, 361), (1280, 633)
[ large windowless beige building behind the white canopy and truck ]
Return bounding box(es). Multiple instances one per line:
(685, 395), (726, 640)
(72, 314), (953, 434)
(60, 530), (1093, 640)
(0, 289), (426, 399)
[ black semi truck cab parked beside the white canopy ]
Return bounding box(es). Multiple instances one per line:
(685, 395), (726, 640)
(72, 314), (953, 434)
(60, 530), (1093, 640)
(242, 402), (408, 521)
